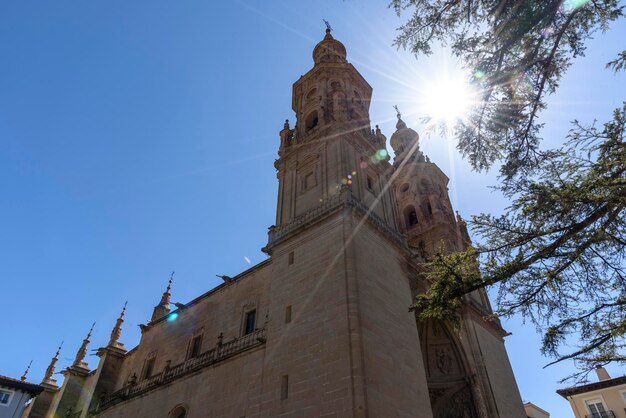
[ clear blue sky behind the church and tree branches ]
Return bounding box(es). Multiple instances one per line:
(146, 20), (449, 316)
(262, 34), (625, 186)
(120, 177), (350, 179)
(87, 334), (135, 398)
(0, 0), (626, 418)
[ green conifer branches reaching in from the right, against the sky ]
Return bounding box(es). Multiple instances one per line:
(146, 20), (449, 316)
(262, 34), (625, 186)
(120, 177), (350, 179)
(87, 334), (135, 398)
(391, 0), (626, 378)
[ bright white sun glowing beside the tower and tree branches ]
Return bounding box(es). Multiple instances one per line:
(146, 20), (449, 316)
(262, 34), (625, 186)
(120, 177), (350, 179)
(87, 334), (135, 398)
(423, 74), (476, 125)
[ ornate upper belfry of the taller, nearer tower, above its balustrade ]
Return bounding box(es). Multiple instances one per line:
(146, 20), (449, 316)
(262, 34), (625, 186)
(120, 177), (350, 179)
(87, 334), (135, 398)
(275, 29), (397, 230)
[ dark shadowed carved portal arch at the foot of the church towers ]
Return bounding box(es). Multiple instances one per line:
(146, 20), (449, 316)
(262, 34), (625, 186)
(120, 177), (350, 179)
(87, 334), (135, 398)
(419, 320), (479, 418)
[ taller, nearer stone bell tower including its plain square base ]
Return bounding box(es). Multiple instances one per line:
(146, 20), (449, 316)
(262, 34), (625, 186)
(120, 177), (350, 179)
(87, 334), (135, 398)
(264, 29), (431, 418)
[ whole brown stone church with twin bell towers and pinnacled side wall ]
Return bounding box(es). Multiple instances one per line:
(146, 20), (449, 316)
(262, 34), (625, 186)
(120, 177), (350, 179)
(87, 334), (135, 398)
(23, 28), (526, 418)
